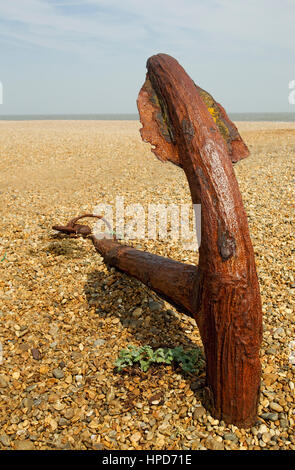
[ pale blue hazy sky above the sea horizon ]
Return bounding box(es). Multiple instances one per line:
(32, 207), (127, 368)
(0, 0), (295, 115)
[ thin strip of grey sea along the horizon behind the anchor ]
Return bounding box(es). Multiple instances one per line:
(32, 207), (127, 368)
(0, 112), (295, 122)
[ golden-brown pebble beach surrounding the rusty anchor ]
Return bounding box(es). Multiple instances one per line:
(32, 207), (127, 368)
(0, 121), (295, 450)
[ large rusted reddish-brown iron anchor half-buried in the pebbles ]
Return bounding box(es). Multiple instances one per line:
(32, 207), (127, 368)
(55, 54), (262, 427)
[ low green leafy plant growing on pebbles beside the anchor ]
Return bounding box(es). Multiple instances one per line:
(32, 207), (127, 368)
(115, 345), (204, 372)
